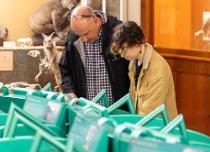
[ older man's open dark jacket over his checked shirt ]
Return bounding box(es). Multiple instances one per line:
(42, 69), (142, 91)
(59, 16), (130, 101)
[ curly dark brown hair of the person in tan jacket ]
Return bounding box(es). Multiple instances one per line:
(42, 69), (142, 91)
(111, 21), (145, 54)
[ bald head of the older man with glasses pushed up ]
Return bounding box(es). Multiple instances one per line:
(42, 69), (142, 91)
(71, 6), (101, 42)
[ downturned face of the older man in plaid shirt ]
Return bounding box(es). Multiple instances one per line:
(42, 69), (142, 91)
(71, 18), (98, 42)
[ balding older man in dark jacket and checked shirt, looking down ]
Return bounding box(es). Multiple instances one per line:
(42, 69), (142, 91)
(59, 6), (129, 104)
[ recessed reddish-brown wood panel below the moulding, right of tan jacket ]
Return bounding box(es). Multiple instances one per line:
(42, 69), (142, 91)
(176, 72), (210, 134)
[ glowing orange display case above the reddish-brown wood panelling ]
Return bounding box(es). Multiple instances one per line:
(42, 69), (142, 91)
(154, 0), (210, 50)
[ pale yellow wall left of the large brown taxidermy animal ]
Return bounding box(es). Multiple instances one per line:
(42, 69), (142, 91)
(0, 0), (47, 40)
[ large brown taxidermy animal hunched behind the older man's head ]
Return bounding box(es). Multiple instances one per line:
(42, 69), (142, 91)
(29, 0), (80, 37)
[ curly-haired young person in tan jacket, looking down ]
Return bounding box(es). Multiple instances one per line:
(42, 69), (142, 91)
(112, 21), (177, 119)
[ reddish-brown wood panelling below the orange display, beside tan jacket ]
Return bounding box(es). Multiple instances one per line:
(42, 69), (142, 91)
(158, 49), (210, 135)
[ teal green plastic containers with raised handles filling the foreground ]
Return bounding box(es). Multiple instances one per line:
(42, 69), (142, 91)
(0, 84), (210, 152)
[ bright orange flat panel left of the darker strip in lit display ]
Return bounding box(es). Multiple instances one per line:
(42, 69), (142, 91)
(154, 0), (191, 48)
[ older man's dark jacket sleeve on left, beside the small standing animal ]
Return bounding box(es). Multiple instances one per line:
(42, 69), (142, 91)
(58, 42), (74, 93)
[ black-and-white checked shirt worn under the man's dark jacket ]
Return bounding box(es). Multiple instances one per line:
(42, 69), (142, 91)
(84, 26), (113, 105)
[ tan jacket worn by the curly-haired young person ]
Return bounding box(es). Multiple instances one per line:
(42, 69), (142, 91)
(129, 43), (177, 119)
